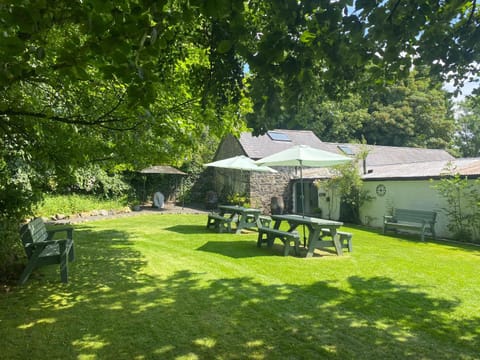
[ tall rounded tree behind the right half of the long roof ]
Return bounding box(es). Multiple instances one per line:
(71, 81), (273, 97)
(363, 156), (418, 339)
(357, 72), (454, 148)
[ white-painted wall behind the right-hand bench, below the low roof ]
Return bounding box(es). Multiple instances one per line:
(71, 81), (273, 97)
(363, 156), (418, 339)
(360, 180), (450, 238)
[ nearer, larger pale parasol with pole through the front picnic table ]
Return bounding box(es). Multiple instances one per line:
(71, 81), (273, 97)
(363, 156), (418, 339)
(256, 145), (352, 241)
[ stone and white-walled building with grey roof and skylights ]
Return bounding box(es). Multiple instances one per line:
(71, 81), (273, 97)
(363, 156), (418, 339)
(215, 130), (480, 237)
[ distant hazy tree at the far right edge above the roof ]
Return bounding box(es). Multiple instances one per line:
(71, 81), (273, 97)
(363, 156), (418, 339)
(455, 94), (480, 157)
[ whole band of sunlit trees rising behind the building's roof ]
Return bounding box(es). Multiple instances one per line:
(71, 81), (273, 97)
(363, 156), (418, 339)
(292, 71), (455, 148)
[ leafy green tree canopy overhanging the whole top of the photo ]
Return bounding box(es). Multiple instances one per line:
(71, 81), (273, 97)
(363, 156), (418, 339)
(0, 0), (480, 270)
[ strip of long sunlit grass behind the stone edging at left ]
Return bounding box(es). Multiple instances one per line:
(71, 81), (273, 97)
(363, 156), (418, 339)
(35, 194), (127, 217)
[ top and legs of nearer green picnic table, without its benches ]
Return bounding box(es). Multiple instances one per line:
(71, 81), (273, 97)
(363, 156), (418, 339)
(272, 214), (343, 258)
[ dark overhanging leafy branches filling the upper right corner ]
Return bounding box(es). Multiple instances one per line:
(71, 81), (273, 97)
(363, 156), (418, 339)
(247, 0), (480, 132)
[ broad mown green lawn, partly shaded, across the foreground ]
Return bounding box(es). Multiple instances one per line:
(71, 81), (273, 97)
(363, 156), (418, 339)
(0, 215), (480, 359)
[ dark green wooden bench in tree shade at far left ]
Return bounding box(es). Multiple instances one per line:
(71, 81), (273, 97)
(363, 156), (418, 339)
(18, 218), (75, 285)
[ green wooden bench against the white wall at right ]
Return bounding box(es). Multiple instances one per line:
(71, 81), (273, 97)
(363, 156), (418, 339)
(383, 209), (437, 241)
